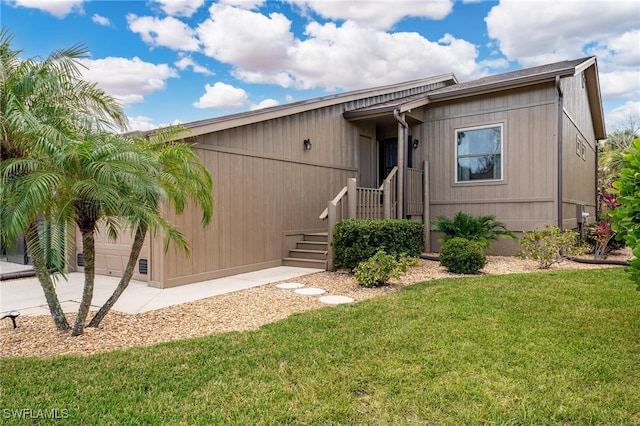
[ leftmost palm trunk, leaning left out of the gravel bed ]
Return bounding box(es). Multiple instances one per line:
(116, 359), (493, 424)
(26, 220), (70, 331)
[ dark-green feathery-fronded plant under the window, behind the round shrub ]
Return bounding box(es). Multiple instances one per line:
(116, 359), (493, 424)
(431, 212), (517, 248)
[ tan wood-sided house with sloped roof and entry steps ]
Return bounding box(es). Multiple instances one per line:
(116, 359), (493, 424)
(76, 57), (606, 288)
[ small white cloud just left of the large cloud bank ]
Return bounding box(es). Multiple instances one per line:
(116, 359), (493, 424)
(127, 13), (199, 51)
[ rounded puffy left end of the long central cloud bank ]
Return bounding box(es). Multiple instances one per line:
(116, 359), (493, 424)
(196, 3), (293, 70)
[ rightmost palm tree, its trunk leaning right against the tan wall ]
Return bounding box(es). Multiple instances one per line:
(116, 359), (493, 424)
(89, 127), (214, 327)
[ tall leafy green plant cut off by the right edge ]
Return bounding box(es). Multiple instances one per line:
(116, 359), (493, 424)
(609, 138), (640, 290)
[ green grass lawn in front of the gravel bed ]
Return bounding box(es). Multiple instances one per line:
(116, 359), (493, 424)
(0, 269), (640, 425)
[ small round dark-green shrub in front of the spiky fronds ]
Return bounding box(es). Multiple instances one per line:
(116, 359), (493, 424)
(440, 237), (487, 274)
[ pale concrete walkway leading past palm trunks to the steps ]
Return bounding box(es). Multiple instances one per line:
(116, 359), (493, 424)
(0, 261), (322, 317)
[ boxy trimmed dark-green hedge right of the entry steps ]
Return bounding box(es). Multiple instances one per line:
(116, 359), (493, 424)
(333, 219), (424, 270)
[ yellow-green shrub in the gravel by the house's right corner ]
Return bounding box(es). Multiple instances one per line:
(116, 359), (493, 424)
(518, 225), (582, 269)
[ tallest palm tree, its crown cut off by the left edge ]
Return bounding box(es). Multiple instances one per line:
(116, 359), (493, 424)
(0, 29), (126, 330)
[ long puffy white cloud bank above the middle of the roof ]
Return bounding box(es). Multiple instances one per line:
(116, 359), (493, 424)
(197, 4), (481, 90)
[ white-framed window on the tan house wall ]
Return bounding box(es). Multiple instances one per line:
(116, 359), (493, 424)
(456, 124), (502, 182)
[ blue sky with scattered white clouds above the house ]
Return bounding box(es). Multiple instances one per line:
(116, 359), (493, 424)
(0, 0), (640, 131)
